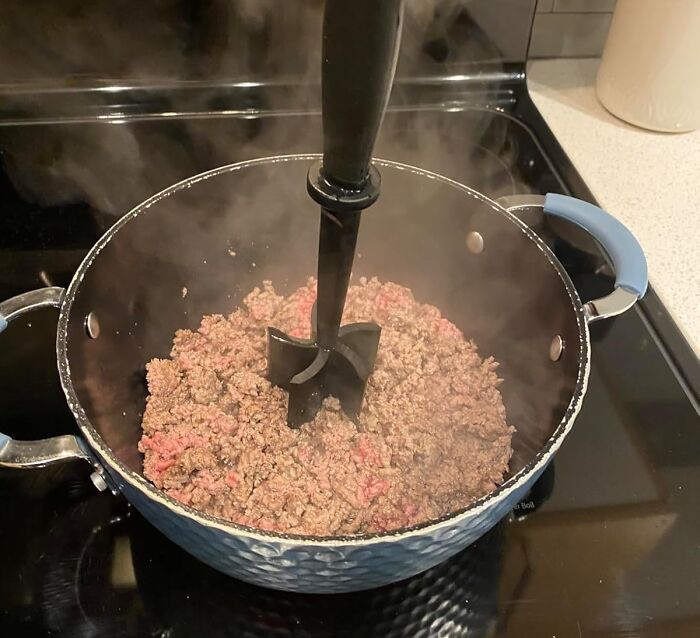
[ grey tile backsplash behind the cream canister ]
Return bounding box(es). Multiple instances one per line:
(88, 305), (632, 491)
(529, 0), (617, 58)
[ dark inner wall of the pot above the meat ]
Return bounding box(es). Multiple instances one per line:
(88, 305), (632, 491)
(67, 156), (586, 490)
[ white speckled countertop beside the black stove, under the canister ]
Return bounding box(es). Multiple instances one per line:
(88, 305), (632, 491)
(528, 59), (700, 356)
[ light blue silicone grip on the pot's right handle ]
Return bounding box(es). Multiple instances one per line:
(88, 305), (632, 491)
(544, 193), (649, 297)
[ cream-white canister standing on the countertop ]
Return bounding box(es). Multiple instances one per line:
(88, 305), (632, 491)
(596, 0), (700, 132)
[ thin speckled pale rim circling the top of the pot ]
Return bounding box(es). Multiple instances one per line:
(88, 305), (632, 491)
(56, 153), (590, 548)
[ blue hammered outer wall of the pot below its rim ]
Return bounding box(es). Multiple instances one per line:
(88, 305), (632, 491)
(113, 467), (544, 593)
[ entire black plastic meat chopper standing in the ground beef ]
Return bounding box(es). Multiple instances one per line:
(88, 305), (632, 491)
(267, 0), (403, 428)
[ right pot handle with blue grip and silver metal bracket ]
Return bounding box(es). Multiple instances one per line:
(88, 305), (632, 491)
(544, 193), (649, 323)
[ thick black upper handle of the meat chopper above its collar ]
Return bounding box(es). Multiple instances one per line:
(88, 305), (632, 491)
(321, 0), (403, 189)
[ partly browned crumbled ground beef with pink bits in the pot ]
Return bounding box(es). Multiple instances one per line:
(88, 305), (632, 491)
(139, 279), (513, 536)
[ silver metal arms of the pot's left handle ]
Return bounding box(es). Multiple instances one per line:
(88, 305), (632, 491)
(0, 287), (107, 489)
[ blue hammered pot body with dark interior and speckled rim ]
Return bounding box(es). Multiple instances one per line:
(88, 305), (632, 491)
(0, 155), (646, 592)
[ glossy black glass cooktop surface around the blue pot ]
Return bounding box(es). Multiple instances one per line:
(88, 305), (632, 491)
(0, 74), (700, 638)
